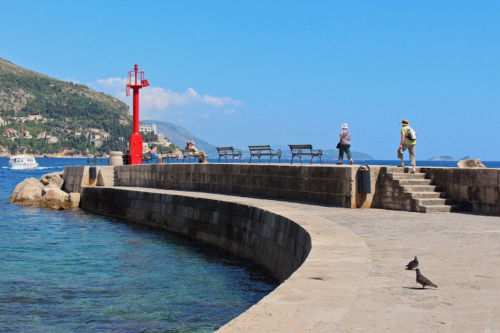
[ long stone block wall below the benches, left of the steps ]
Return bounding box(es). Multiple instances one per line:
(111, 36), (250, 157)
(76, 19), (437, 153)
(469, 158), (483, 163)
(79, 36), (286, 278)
(115, 163), (358, 207)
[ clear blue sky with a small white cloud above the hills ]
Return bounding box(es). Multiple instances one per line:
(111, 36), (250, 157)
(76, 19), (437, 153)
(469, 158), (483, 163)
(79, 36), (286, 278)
(0, 0), (500, 161)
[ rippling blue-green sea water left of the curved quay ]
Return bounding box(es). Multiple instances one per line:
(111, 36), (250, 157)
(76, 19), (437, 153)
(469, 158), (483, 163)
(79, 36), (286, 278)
(0, 158), (276, 332)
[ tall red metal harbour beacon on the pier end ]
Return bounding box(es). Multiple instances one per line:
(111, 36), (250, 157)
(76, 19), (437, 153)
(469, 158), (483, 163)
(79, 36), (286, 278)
(127, 64), (149, 164)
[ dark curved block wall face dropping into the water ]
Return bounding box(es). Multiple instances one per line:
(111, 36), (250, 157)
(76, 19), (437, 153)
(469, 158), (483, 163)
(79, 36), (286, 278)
(81, 187), (312, 282)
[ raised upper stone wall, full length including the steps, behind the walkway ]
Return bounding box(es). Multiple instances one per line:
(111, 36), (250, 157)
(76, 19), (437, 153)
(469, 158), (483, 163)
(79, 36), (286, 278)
(64, 163), (500, 215)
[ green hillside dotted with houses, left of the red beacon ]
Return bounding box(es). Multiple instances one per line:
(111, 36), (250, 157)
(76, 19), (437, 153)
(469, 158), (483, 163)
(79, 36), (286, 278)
(0, 58), (132, 155)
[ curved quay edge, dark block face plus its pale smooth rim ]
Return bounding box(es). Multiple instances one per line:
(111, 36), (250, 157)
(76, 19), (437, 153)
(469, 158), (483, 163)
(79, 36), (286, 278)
(81, 187), (371, 333)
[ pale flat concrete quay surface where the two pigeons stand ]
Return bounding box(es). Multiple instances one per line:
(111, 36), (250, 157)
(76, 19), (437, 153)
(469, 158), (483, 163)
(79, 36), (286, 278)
(78, 188), (500, 333)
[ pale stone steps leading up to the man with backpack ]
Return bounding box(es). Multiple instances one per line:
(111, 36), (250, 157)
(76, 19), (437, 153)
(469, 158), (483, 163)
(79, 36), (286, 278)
(387, 168), (459, 213)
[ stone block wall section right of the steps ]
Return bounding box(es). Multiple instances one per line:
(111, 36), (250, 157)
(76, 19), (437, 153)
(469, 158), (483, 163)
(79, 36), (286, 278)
(421, 168), (500, 215)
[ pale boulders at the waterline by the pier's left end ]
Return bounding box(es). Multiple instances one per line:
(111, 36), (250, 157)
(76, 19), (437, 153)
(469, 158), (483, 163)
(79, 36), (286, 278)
(9, 172), (80, 210)
